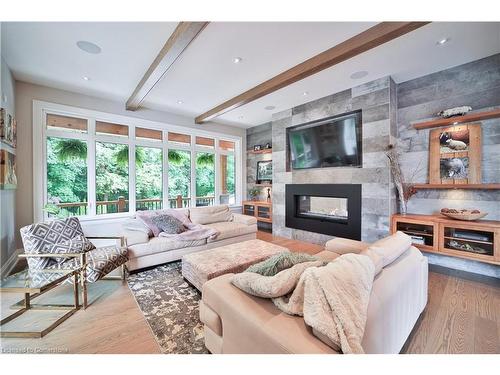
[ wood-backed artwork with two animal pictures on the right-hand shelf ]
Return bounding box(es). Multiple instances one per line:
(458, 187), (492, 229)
(429, 124), (481, 185)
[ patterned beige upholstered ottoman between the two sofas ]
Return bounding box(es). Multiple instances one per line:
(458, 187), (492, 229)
(182, 240), (288, 291)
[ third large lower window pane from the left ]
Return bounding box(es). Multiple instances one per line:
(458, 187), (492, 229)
(135, 146), (163, 211)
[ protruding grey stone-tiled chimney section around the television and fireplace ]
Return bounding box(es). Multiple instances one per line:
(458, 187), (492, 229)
(272, 77), (396, 244)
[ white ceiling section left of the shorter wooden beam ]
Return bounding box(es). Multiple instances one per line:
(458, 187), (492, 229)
(2, 22), (177, 101)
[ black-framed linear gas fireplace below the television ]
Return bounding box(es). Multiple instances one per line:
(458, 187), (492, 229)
(285, 184), (361, 240)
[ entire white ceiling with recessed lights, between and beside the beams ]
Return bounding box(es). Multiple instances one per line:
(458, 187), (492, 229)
(2, 22), (500, 128)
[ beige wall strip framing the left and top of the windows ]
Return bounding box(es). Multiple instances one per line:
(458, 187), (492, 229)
(16, 81), (246, 244)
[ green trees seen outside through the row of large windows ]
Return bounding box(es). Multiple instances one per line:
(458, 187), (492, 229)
(45, 137), (228, 217)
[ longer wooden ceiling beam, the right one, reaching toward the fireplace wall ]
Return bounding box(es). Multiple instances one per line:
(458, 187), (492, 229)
(195, 22), (429, 124)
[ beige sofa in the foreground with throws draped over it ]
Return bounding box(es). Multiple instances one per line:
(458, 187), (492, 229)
(200, 238), (428, 354)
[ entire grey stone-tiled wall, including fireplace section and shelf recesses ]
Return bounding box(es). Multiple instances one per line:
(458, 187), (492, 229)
(247, 54), (500, 277)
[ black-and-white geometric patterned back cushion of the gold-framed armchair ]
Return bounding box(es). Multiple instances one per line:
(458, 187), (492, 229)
(20, 217), (83, 270)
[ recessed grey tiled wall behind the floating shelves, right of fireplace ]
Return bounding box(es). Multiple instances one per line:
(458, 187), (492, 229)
(397, 54), (500, 277)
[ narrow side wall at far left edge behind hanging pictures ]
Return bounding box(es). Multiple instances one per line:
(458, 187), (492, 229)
(0, 57), (16, 266)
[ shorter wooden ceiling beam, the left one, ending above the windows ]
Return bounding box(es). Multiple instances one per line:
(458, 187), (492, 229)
(126, 22), (208, 111)
